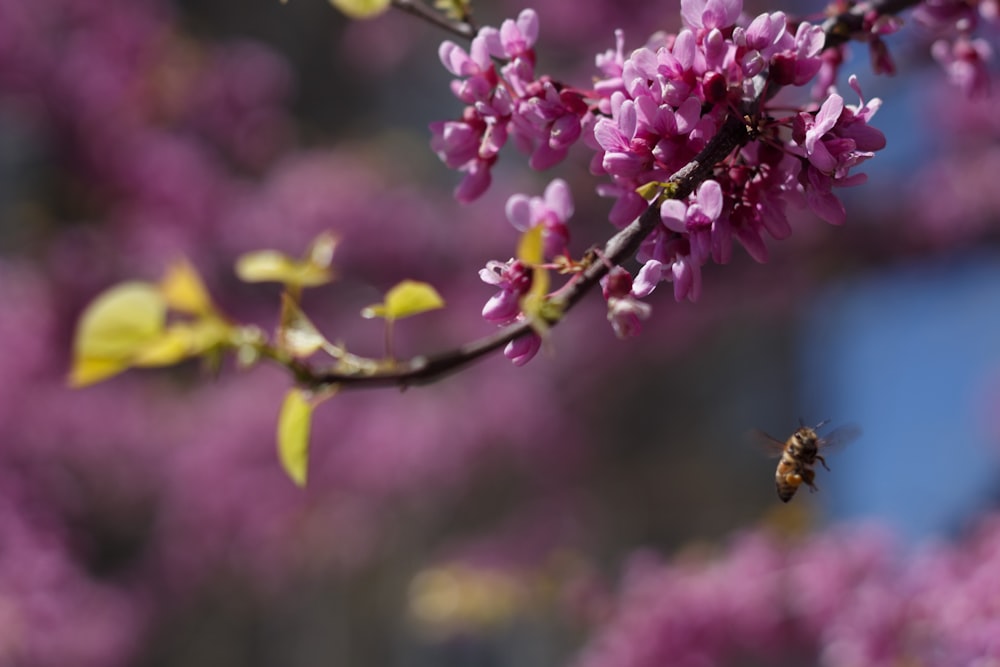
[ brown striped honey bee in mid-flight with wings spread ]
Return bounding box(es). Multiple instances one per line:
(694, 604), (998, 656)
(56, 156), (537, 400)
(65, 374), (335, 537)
(757, 419), (861, 503)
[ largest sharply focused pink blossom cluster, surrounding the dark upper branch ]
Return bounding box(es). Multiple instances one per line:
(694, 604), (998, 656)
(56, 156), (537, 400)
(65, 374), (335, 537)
(592, 0), (885, 300)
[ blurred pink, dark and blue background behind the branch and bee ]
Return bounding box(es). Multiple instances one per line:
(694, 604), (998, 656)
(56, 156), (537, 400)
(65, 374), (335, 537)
(0, 0), (1000, 667)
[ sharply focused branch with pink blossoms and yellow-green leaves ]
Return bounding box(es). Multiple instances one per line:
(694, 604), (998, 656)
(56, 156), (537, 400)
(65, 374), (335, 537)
(73, 2), (908, 482)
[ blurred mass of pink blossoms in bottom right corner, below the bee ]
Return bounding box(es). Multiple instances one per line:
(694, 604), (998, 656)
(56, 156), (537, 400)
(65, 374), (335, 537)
(577, 517), (1000, 667)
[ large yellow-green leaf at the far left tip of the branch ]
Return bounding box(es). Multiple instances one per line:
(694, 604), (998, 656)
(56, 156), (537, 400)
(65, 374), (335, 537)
(69, 281), (167, 387)
